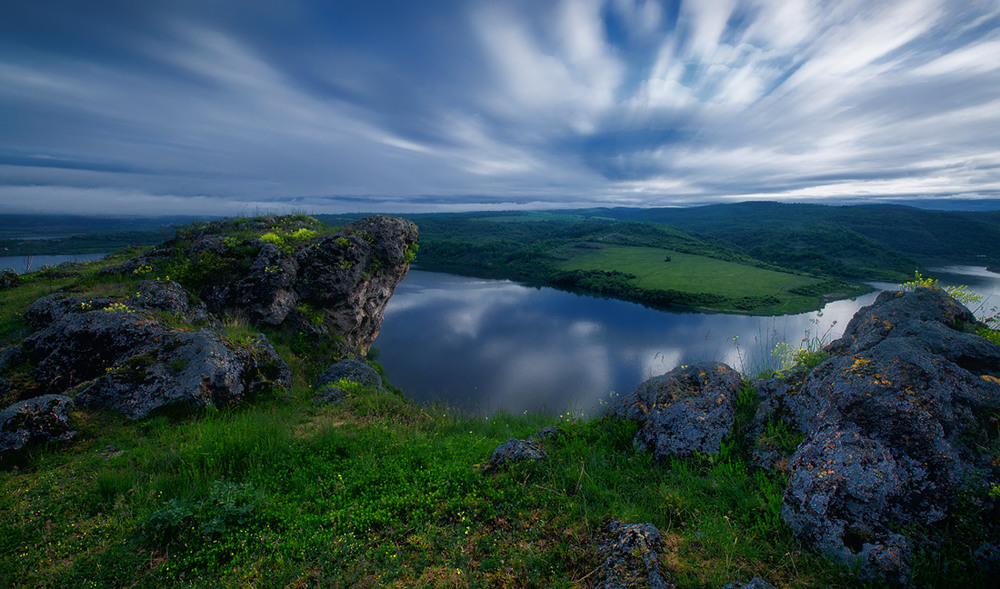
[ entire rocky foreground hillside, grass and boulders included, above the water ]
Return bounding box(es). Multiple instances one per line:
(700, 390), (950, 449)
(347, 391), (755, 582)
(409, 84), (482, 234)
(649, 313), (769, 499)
(0, 216), (1000, 589)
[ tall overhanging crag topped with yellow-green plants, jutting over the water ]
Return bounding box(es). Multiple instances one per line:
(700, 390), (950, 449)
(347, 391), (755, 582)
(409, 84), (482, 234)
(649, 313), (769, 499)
(115, 215), (418, 354)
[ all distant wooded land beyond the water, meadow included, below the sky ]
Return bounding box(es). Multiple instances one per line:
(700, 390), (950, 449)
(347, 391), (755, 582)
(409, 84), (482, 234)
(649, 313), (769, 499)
(0, 202), (1000, 313)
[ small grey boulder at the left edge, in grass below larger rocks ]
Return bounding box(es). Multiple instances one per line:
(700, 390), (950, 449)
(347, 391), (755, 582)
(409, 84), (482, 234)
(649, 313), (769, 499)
(0, 395), (76, 454)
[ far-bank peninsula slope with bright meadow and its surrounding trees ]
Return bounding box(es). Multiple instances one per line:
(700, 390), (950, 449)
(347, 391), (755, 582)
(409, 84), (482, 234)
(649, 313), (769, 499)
(406, 212), (861, 313)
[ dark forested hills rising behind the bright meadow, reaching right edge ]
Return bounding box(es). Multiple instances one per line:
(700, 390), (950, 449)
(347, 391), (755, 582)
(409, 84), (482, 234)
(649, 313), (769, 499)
(574, 202), (1000, 277)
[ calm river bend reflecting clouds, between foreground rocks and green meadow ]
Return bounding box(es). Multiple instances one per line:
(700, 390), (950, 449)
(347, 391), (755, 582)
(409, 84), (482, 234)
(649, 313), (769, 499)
(375, 266), (1000, 415)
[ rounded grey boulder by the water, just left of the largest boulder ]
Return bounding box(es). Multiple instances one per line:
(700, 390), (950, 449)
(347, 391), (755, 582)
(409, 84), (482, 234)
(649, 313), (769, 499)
(608, 362), (741, 459)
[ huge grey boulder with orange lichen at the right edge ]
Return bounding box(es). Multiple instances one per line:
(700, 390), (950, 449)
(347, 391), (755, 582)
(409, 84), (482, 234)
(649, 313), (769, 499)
(758, 288), (1000, 585)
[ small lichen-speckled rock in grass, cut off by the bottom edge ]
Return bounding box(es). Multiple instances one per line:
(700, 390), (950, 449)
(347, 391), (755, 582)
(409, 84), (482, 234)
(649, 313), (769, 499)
(597, 520), (674, 589)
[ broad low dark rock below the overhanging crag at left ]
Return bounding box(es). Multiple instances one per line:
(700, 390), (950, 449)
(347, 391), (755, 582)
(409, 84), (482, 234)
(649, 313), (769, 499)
(21, 284), (291, 419)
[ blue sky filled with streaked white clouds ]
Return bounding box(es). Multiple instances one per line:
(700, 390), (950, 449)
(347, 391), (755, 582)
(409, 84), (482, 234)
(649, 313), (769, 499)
(0, 0), (1000, 215)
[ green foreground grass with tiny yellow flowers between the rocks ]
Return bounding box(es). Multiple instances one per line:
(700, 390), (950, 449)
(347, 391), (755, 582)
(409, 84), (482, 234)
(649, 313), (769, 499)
(0, 242), (992, 587)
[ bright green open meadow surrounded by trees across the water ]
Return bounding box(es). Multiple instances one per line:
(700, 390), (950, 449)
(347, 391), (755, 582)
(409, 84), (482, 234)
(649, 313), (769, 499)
(560, 246), (823, 313)
